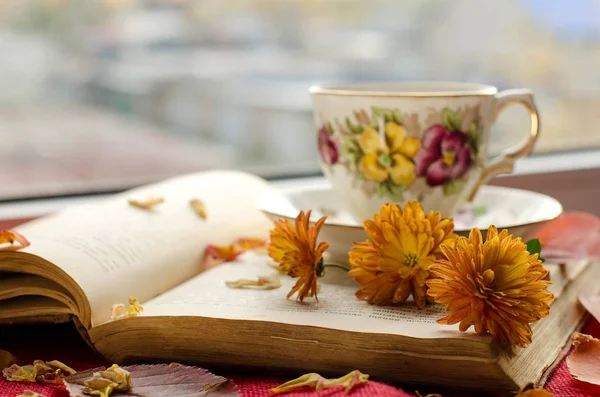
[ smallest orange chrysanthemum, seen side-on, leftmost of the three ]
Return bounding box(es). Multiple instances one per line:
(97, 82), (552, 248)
(268, 211), (329, 302)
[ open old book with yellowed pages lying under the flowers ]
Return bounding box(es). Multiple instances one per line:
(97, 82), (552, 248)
(0, 171), (600, 390)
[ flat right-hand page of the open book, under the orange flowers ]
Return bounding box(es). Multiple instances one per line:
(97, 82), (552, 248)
(142, 252), (472, 338)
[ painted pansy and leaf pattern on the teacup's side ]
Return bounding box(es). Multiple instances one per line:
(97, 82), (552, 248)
(318, 107), (482, 200)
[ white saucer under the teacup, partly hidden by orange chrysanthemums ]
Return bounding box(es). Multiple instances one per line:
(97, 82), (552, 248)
(257, 181), (562, 263)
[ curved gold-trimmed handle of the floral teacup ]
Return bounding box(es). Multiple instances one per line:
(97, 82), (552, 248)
(467, 89), (540, 202)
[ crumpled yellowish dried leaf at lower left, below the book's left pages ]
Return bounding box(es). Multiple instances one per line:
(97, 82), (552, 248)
(2, 360), (77, 384)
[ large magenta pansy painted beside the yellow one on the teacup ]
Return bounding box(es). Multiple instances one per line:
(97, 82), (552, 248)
(415, 124), (472, 186)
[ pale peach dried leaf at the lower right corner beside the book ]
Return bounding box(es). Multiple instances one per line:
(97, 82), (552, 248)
(567, 332), (600, 385)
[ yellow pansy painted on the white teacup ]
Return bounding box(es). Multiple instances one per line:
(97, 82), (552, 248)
(358, 121), (420, 185)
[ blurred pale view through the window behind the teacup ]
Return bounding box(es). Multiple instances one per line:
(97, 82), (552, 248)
(0, 0), (600, 200)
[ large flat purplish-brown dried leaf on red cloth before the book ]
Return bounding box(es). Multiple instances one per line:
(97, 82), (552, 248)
(65, 364), (240, 397)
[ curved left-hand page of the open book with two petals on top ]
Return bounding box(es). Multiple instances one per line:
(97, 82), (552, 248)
(18, 171), (272, 324)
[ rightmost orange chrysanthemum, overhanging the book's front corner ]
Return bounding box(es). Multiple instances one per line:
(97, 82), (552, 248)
(427, 226), (554, 347)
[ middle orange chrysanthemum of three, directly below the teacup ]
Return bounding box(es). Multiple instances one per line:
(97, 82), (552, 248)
(349, 201), (454, 308)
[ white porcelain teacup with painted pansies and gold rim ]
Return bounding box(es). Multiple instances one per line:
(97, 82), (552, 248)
(310, 82), (539, 220)
